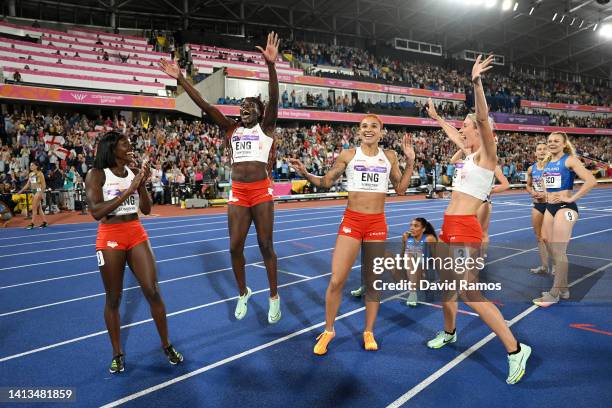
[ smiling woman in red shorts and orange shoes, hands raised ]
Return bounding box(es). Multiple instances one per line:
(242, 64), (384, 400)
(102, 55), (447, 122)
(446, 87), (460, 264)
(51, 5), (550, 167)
(289, 115), (415, 355)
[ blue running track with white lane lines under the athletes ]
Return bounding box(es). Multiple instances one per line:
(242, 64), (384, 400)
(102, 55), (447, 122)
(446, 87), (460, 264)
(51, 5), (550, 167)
(0, 188), (612, 408)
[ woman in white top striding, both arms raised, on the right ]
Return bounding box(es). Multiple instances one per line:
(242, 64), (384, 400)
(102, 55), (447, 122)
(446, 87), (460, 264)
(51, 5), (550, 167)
(427, 56), (531, 384)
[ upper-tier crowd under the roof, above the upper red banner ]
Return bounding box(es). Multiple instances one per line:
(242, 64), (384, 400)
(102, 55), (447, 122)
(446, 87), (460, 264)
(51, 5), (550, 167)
(283, 41), (611, 108)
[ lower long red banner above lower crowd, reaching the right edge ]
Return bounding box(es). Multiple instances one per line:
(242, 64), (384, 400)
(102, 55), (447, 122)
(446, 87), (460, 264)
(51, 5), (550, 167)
(215, 105), (612, 135)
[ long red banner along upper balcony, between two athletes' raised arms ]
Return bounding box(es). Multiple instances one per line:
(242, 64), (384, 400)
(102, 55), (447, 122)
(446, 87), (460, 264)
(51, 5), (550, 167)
(225, 68), (465, 101)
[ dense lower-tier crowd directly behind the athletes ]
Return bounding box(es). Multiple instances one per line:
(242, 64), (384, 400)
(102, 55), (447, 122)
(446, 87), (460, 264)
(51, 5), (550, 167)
(0, 113), (612, 202)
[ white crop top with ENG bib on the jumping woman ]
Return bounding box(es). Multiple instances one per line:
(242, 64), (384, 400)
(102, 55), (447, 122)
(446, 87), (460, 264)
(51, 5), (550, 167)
(231, 124), (274, 163)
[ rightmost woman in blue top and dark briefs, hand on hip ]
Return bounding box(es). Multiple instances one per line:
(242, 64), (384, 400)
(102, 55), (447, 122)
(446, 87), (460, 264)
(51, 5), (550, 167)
(533, 132), (597, 307)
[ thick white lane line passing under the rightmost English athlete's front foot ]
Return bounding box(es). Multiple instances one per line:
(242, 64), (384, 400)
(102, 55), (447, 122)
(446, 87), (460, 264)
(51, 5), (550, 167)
(387, 262), (612, 408)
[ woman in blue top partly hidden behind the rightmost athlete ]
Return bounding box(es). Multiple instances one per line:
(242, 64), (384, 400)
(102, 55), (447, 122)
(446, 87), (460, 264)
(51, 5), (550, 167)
(526, 142), (548, 273)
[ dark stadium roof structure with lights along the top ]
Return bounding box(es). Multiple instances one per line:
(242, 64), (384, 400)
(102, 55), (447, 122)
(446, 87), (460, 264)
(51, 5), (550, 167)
(8, 0), (612, 78)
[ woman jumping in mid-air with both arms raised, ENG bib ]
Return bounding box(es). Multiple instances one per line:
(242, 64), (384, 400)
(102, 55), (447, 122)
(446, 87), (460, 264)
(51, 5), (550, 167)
(160, 32), (281, 324)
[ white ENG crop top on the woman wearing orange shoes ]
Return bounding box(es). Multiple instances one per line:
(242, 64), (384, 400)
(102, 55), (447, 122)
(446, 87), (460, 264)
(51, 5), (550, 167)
(345, 147), (391, 193)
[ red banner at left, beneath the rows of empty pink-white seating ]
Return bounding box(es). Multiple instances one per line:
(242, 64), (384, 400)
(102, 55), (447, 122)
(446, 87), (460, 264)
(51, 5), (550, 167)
(0, 85), (176, 110)
